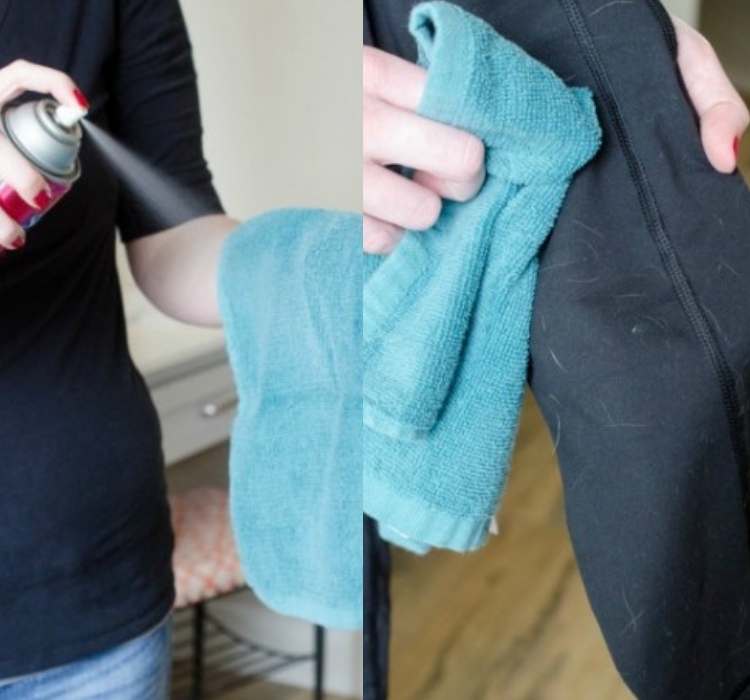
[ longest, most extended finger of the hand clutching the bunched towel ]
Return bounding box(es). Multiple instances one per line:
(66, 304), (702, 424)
(363, 100), (484, 184)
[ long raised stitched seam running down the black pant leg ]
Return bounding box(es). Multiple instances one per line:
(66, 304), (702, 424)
(560, 0), (750, 537)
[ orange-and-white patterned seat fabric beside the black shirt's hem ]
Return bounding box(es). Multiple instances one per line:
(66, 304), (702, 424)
(169, 487), (245, 608)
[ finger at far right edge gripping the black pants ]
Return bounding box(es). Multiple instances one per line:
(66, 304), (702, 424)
(673, 18), (750, 173)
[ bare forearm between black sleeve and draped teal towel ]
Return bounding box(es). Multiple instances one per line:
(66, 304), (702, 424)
(127, 214), (239, 326)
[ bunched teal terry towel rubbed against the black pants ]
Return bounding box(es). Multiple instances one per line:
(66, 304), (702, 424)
(363, 2), (601, 553)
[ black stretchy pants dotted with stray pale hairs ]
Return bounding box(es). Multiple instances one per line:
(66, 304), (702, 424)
(365, 0), (750, 700)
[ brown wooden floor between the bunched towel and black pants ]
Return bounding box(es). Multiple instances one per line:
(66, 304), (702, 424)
(390, 397), (633, 700)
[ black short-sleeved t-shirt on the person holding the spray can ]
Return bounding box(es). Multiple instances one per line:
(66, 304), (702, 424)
(0, 0), (221, 679)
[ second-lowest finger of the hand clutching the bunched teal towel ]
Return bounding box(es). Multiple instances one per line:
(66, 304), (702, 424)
(363, 163), (442, 231)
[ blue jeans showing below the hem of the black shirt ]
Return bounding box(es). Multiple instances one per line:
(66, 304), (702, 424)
(0, 616), (172, 700)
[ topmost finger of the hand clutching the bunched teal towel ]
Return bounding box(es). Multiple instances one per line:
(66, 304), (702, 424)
(362, 46), (427, 111)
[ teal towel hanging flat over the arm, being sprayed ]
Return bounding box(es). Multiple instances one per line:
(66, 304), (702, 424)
(218, 209), (362, 629)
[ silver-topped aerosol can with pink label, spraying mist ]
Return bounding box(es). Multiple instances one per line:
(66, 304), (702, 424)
(0, 98), (86, 229)
